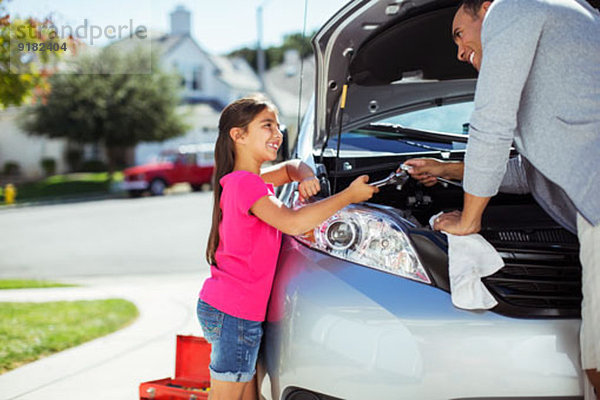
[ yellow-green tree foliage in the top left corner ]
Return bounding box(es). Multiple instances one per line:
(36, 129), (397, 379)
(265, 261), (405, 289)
(0, 0), (68, 110)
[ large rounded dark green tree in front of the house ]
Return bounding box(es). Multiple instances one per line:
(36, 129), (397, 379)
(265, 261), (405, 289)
(22, 47), (188, 173)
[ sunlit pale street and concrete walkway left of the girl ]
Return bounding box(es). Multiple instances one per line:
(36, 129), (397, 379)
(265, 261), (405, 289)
(0, 192), (217, 400)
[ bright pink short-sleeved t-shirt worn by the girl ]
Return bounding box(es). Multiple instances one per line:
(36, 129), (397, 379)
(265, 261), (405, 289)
(200, 171), (281, 321)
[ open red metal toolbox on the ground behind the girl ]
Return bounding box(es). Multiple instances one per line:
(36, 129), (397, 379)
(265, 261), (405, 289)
(140, 335), (210, 400)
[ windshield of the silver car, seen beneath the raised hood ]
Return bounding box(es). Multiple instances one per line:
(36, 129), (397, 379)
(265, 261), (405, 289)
(327, 102), (473, 153)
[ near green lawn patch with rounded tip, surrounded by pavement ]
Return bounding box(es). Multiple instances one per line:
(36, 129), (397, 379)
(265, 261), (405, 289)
(0, 299), (138, 373)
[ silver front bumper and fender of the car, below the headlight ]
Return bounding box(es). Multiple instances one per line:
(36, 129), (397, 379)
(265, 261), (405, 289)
(262, 237), (582, 400)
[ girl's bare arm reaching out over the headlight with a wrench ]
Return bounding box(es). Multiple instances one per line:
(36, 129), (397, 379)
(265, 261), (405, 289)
(250, 175), (379, 235)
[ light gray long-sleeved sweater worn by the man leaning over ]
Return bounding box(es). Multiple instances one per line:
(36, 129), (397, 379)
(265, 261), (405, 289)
(463, 0), (600, 225)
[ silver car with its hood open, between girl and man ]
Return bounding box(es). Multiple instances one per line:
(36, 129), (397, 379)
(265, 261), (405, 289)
(261, 0), (583, 400)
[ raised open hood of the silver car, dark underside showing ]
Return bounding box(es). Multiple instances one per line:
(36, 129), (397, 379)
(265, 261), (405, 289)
(312, 0), (476, 147)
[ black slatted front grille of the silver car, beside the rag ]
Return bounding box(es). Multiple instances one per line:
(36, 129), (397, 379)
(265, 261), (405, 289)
(482, 228), (582, 318)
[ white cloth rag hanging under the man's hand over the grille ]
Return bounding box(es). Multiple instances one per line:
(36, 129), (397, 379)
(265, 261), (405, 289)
(429, 212), (504, 310)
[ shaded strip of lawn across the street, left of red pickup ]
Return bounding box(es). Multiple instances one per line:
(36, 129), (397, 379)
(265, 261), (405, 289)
(8, 172), (123, 202)
